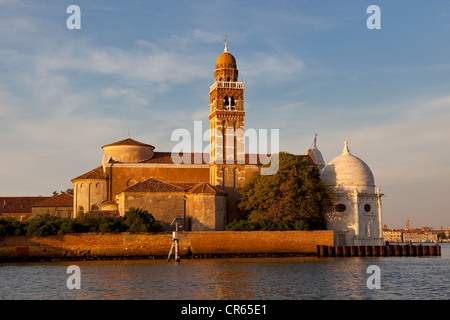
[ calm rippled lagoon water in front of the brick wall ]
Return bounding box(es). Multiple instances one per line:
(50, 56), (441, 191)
(0, 243), (450, 300)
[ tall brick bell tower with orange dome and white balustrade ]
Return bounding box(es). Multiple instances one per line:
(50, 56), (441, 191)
(209, 42), (245, 188)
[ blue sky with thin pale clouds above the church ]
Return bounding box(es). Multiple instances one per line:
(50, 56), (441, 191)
(0, 0), (450, 228)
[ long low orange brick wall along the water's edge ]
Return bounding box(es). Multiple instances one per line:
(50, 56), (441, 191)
(0, 231), (334, 259)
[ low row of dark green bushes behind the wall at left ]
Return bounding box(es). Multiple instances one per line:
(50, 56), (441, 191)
(0, 208), (163, 237)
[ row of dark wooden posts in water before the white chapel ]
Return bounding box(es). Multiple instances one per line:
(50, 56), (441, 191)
(317, 244), (441, 257)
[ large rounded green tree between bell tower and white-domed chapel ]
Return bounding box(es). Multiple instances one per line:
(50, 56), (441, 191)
(227, 152), (334, 230)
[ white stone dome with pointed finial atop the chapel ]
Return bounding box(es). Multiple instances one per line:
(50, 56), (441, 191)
(322, 141), (375, 193)
